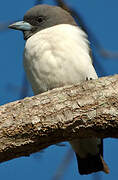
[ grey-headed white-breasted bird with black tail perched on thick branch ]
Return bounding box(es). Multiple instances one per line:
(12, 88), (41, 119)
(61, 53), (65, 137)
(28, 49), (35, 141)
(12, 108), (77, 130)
(9, 4), (109, 175)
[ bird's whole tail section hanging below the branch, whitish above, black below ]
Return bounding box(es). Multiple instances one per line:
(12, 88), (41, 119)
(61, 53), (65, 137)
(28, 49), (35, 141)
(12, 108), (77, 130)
(70, 138), (109, 174)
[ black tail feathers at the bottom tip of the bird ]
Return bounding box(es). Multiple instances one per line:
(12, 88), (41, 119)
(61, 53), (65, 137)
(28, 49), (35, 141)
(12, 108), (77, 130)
(76, 154), (109, 174)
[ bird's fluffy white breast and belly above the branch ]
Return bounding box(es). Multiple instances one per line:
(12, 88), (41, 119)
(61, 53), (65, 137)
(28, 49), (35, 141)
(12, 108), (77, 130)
(24, 24), (97, 94)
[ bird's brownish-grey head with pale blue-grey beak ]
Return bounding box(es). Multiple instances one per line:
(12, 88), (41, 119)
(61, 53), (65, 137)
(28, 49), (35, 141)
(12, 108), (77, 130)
(9, 5), (76, 40)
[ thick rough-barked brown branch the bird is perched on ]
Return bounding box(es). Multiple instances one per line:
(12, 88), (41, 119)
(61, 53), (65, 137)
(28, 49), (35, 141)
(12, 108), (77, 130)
(0, 75), (118, 162)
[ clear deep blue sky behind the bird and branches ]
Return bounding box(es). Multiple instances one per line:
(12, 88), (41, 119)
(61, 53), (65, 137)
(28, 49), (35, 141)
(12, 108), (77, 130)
(0, 0), (118, 180)
